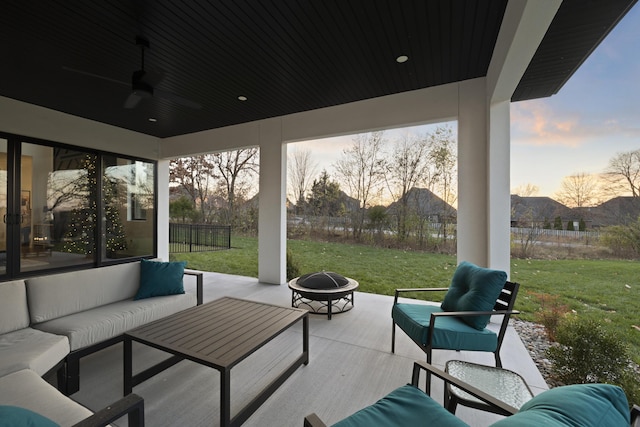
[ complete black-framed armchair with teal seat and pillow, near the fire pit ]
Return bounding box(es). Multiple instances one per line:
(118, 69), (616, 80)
(391, 261), (520, 392)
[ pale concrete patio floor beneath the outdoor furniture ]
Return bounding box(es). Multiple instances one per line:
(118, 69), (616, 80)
(65, 273), (547, 427)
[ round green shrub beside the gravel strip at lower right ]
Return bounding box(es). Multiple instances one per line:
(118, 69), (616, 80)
(547, 317), (640, 403)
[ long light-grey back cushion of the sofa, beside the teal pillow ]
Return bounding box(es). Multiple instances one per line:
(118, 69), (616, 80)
(26, 262), (140, 324)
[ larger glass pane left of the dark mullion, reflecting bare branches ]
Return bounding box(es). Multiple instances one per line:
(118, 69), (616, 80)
(20, 143), (97, 271)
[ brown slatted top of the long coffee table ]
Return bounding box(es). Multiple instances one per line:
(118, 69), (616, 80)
(126, 297), (307, 369)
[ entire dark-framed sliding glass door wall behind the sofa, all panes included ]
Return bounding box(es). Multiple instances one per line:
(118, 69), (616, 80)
(0, 134), (156, 280)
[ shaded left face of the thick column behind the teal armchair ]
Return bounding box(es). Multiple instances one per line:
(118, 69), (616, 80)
(458, 78), (489, 267)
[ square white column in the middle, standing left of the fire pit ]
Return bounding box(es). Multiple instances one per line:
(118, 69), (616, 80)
(258, 119), (287, 285)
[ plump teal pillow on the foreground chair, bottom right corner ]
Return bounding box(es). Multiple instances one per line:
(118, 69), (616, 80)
(492, 384), (630, 427)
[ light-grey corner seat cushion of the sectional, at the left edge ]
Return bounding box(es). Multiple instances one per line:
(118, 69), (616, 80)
(0, 328), (69, 376)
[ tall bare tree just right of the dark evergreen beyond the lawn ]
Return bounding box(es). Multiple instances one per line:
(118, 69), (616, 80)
(335, 132), (385, 238)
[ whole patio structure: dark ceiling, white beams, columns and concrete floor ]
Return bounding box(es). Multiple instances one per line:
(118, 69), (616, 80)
(0, 0), (637, 426)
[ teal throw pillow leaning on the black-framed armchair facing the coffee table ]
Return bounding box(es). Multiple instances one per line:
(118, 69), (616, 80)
(441, 261), (507, 330)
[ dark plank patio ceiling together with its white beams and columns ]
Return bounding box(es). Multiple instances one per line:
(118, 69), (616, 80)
(0, 0), (636, 284)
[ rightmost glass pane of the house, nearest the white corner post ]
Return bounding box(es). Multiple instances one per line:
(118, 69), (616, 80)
(102, 156), (155, 259)
